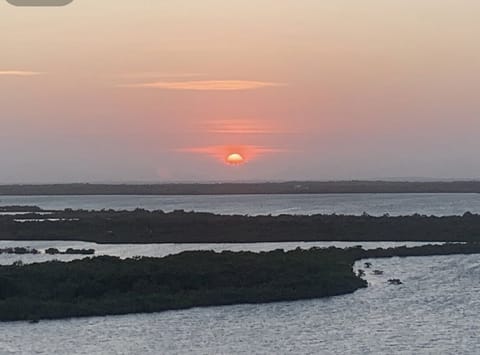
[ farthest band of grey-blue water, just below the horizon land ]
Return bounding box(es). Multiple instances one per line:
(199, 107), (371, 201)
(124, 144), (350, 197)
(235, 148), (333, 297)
(0, 194), (480, 216)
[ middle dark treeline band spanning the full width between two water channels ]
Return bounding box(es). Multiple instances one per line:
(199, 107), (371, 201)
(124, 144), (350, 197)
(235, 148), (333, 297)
(0, 210), (480, 243)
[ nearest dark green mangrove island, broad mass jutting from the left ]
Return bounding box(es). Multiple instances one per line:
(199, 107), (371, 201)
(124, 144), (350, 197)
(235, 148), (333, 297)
(0, 249), (367, 321)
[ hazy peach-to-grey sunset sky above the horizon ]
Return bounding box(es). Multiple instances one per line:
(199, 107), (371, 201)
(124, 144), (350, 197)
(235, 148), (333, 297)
(0, 0), (480, 183)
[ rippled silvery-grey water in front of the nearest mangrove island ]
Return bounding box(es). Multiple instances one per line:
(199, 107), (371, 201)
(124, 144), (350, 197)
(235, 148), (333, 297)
(0, 255), (480, 355)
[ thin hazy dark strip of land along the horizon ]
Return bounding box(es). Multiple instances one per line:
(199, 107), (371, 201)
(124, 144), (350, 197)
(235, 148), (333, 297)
(0, 180), (480, 196)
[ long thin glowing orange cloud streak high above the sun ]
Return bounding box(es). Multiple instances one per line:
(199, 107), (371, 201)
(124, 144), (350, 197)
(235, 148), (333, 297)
(125, 80), (284, 91)
